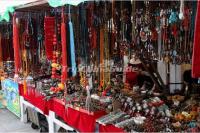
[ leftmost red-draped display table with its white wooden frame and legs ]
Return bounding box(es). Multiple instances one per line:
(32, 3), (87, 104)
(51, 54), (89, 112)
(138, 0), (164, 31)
(19, 84), (74, 133)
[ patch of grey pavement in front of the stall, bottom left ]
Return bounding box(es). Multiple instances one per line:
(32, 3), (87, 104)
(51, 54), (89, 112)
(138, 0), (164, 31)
(0, 109), (38, 133)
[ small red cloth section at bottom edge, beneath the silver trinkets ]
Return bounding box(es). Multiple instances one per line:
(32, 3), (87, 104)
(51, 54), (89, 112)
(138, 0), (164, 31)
(99, 124), (125, 133)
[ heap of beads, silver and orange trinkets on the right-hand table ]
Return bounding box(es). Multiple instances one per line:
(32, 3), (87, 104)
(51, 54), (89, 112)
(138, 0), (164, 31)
(97, 93), (200, 132)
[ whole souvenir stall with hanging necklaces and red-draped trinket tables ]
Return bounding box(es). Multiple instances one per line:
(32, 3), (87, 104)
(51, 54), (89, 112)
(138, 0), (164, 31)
(0, 0), (200, 132)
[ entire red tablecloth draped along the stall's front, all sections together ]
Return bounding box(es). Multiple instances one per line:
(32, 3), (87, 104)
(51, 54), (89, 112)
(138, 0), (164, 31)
(19, 85), (123, 132)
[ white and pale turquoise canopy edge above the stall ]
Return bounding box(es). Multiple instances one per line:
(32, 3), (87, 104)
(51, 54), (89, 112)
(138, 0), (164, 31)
(0, 0), (85, 21)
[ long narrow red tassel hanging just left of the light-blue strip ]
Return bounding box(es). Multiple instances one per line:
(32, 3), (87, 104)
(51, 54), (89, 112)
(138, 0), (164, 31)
(61, 8), (68, 83)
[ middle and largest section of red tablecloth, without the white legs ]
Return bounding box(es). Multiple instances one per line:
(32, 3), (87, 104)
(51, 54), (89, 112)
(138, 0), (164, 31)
(51, 99), (105, 132)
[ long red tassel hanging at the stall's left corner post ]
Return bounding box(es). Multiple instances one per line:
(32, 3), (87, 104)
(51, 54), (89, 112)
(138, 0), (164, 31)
(13, 13), (20, 74)
